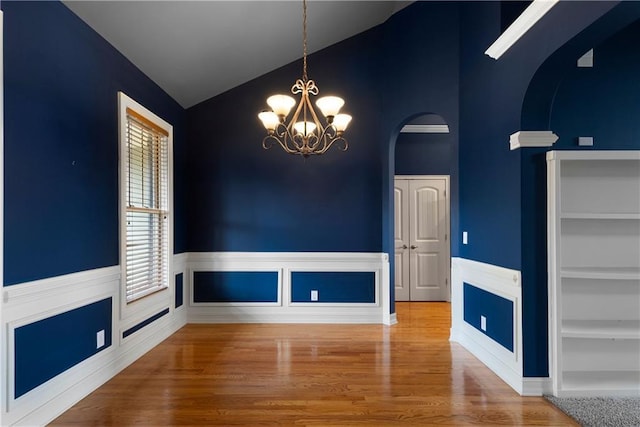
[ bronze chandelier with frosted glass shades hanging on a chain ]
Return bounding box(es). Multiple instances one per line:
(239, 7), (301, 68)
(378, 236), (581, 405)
(258, 0), (351, 157)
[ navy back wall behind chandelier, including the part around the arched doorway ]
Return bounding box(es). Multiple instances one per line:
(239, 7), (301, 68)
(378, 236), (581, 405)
(188, 2), (459, 316)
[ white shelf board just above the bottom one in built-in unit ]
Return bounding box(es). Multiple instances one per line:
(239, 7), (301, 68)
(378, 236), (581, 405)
(561, 320), (640, 340)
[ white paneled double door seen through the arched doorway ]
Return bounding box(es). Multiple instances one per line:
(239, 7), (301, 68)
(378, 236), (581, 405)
(394, 176), (450, 301)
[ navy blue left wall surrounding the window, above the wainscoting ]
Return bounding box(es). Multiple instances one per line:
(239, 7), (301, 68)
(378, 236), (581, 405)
(2, 1), (186, 285)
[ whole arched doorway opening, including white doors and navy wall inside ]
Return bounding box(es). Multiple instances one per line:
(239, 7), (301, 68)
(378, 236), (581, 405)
(393, 113), (452, 301)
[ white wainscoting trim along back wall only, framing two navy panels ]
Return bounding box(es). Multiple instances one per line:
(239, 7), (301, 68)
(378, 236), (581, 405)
(185, 252), (395, 325)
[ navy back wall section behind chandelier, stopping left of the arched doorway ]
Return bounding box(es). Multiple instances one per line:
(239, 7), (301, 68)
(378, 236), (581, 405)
(188, 27), (381, 252)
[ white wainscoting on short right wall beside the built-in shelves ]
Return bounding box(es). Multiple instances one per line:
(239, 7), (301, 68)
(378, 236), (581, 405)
(451, 258), (549, 396)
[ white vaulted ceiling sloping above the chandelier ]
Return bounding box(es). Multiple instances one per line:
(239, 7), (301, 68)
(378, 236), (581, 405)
(64, 0), (412, 108)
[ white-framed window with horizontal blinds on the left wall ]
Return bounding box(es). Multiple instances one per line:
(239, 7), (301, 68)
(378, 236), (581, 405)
(120, 93), (172, 303)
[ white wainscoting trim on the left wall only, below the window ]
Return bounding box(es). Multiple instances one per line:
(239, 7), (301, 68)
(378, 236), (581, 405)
(1, 260), (188, 425)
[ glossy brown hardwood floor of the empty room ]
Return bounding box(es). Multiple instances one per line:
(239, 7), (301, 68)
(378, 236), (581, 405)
(51, 303), (577, 426)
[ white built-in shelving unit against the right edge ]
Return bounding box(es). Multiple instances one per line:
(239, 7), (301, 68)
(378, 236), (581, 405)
(547, 151), (640, 396)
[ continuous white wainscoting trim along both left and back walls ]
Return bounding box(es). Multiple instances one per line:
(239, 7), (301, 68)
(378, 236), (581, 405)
(0, 252), (396, 426)
